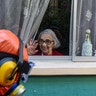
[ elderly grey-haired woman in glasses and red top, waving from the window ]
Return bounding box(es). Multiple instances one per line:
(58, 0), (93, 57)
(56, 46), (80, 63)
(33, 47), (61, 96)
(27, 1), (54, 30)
(27, 29), (63, 56)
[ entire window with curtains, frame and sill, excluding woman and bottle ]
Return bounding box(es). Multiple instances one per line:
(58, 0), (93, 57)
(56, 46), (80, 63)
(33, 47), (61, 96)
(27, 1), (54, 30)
(0, 0), (96, 75)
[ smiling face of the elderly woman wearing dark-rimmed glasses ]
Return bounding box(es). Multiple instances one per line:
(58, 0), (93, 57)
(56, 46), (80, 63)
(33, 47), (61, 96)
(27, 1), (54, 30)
(39, 34), (54, 55)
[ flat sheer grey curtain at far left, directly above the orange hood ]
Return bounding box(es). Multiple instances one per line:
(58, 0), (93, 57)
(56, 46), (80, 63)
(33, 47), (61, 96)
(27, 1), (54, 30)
(0, 0), (22, 35)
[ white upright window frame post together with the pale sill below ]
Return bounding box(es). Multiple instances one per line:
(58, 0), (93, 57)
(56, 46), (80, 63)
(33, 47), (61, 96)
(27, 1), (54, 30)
(29, 0), (96, 75)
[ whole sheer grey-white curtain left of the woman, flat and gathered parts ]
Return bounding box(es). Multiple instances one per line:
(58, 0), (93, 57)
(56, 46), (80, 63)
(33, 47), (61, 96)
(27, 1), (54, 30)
(0, 0), (50, 43)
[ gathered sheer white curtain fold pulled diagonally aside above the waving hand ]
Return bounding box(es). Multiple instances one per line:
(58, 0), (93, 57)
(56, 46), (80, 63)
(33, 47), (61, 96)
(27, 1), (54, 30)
(20, 0), (50, 44)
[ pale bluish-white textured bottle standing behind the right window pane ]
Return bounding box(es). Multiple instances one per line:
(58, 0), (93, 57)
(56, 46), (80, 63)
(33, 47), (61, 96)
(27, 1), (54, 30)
(81, 29), (92, 56)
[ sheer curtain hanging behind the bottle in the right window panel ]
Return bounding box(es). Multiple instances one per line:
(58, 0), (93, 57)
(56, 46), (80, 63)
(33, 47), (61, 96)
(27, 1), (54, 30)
(76, 0), (96, 55)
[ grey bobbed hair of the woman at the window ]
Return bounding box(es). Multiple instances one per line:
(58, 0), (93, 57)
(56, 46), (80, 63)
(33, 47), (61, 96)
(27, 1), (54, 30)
(38, 29), (61, 49)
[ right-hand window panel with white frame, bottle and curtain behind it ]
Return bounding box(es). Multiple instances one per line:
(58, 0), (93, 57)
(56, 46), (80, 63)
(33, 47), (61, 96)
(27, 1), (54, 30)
(73, 0), (96, 61)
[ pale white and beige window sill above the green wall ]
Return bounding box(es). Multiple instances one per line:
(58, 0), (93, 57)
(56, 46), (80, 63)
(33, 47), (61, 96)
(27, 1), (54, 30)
(29, 56), (96, 75)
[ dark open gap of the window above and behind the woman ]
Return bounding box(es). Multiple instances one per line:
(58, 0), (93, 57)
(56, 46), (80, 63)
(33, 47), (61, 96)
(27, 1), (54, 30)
(33, 0), (71, 56)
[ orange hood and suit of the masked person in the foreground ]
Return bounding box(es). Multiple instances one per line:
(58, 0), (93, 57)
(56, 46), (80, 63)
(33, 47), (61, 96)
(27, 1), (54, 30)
(0, 29), (28, 96)
